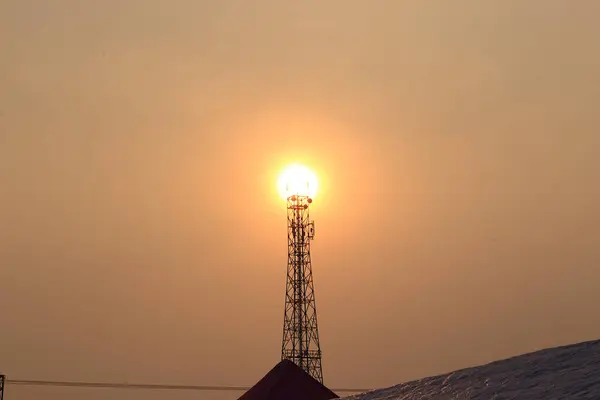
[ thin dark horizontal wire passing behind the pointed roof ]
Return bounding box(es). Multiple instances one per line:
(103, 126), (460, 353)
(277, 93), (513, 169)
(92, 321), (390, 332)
(6, 379), (371, 393)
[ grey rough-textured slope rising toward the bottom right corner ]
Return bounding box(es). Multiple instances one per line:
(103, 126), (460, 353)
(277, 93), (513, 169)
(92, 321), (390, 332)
(345, 340), (600, 400)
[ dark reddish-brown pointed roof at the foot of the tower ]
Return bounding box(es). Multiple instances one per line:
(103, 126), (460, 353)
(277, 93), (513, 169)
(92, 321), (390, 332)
(238, 360), (339, 400)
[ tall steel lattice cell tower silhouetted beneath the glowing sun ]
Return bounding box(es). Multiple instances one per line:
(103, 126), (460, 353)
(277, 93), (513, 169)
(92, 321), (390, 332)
(281, 195), (323, 383)
